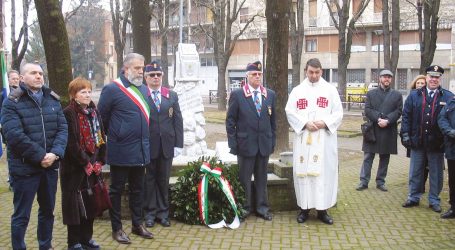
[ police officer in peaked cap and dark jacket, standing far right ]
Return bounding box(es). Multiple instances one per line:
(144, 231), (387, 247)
(400, 65), (453, 213)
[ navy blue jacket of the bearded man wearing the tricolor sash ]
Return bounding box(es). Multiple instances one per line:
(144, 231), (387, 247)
(98, 75), (150, 166)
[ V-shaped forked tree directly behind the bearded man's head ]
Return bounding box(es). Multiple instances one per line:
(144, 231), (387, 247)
(109, 0), (131, 72)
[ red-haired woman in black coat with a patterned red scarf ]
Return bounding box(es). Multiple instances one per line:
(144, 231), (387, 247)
(60, 77), (106, 250)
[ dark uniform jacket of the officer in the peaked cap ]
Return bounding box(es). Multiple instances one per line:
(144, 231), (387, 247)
(400, 87), (453, 152)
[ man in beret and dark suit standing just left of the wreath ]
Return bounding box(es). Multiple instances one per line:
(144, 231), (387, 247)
(143, 61), (183, 227)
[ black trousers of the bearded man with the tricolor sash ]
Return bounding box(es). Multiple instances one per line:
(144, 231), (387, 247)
(109, 165), (145, 232)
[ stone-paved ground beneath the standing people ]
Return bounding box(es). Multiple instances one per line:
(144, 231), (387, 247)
(0, 137), (455, 249)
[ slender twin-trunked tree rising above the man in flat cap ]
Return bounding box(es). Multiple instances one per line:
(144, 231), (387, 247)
(378, 0), (400, 80)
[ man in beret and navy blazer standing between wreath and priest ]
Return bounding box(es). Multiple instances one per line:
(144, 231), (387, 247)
(226, 61), (276, 220)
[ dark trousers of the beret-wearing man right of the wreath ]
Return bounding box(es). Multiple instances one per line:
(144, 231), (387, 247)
(237, 152), (270, 214)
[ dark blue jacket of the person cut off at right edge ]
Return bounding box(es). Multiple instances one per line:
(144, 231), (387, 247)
(438, 99), (455, 160)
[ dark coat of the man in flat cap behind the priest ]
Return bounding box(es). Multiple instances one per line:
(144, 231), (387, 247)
(362, 87), (403, 154)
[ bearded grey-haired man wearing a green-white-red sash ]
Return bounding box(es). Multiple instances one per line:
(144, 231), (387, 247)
(98, 53), (153, 244)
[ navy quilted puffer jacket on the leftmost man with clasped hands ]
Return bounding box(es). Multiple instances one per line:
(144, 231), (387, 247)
(1, 83), (68, 175)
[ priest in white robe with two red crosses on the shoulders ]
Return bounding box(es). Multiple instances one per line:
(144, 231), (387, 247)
(285, 58), (343, 224)
